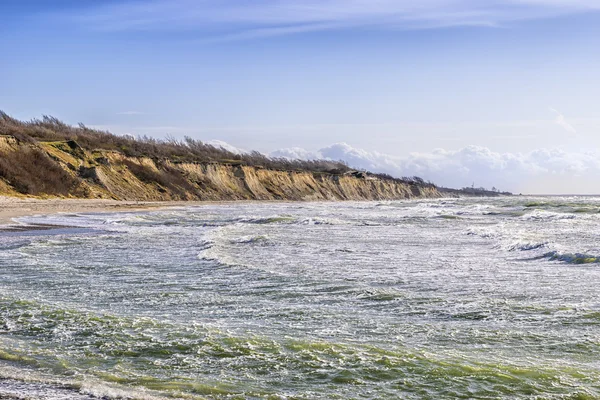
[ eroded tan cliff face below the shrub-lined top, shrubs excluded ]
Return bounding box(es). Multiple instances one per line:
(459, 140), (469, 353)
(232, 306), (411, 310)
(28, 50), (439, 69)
(0, 136), (441, 201)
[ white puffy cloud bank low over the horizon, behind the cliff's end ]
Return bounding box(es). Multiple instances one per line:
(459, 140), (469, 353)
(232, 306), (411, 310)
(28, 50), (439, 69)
(270, 143), (600, 194)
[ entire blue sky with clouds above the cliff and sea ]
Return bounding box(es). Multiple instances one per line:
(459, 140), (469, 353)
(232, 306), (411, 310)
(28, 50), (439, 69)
(0, 0), (600, 194)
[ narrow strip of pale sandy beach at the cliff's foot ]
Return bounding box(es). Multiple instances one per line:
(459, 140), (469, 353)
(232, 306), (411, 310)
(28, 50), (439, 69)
(0, 196), (189, 226)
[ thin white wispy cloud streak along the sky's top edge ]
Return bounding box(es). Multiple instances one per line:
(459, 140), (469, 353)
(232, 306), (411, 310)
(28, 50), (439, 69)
(57, 0), (600, 40)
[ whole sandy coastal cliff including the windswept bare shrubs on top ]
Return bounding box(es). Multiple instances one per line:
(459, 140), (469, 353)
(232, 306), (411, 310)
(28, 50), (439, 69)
(0, 112), (440, 200)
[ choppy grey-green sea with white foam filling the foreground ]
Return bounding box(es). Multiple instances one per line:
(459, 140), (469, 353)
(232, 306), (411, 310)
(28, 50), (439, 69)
(0, 196), (600, 400)
